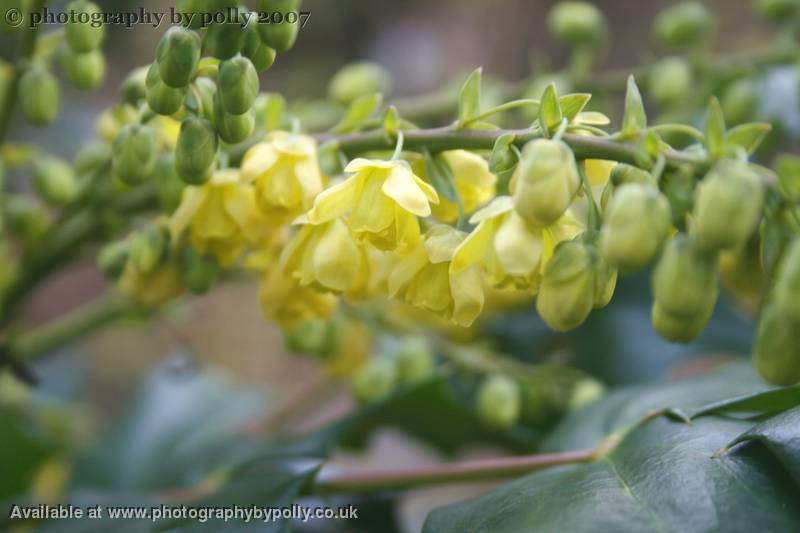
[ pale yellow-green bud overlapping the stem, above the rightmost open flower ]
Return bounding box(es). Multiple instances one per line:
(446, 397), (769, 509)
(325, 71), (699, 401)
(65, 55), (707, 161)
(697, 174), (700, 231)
(511, 139), (581, 226)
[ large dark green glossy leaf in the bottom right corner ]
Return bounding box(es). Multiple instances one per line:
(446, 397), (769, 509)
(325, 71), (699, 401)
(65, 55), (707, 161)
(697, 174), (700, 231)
(423, 366), (800, 533)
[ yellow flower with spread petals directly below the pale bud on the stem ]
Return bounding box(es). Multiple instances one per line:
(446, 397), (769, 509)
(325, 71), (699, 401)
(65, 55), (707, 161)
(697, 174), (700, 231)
(450, 196), (584, 291)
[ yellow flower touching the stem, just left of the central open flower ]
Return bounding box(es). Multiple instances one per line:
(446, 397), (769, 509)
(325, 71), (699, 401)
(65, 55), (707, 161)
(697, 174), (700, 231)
(241, 131), (323, 226)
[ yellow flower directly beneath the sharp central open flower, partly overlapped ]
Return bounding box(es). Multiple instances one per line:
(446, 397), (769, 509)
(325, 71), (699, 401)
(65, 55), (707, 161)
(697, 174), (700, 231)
(280, 217), (369, 298)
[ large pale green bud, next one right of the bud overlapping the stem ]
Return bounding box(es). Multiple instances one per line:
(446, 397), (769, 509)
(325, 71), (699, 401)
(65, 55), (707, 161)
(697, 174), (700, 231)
(599, 183), (672, 272)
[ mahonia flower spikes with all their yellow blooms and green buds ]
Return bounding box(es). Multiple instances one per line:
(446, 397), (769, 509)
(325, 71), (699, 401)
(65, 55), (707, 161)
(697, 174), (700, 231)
(0, 0), (800, 427)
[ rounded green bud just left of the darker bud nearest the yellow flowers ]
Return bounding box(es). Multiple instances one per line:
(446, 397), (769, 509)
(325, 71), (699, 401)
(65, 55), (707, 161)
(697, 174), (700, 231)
(111, 124), (156, 185)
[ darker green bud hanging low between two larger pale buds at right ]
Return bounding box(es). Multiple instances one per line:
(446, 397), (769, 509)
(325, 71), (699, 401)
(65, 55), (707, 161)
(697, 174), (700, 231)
(652, 234), (719, 320)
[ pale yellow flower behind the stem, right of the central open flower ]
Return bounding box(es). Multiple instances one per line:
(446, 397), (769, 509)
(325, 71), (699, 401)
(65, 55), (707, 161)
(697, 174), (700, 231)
(413, 150), (497, 222)
